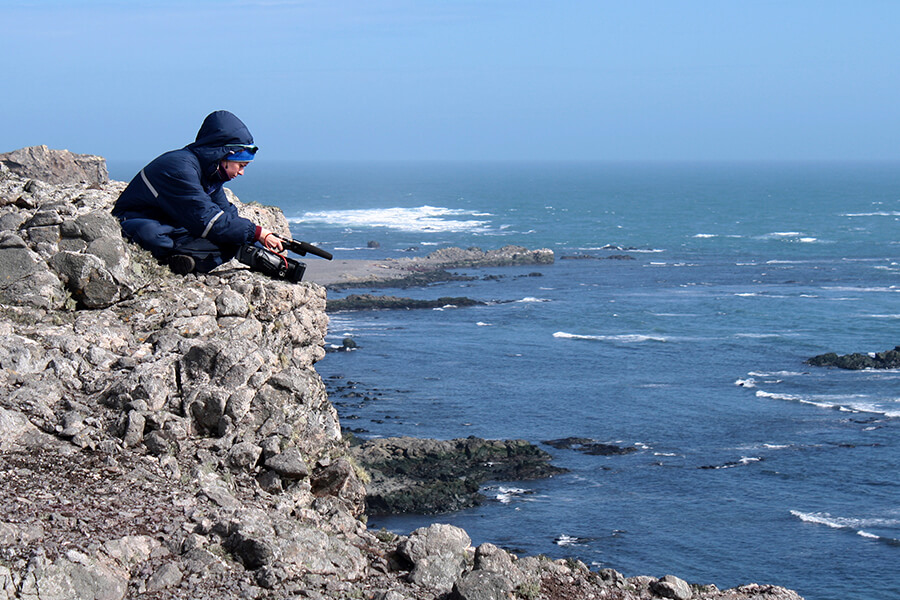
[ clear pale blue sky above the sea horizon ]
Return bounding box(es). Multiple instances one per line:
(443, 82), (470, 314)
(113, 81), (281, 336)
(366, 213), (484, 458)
(0, 0), (900, 160)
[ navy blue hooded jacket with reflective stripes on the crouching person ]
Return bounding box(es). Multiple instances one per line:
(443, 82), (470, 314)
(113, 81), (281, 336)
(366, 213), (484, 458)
(112, 110), (256, 257)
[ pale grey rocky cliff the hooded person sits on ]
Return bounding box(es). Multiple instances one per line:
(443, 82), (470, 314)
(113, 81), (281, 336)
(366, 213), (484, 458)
(0, 147), (799, 600)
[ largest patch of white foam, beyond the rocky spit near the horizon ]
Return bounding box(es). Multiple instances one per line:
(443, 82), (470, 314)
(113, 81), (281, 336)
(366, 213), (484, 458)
(288, 206), (490, 233)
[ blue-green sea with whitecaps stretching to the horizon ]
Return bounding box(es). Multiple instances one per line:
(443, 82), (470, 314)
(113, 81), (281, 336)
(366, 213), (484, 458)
(110, 161), (900, 600)
